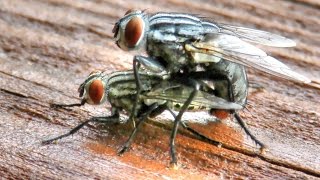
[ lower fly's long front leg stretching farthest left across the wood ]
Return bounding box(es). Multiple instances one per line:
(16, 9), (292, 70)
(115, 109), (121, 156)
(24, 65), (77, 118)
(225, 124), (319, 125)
(42, 110), (119, 144)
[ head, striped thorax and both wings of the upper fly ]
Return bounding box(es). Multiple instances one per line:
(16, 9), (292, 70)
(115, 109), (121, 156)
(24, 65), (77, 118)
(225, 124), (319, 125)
(113, 10), (310, 83)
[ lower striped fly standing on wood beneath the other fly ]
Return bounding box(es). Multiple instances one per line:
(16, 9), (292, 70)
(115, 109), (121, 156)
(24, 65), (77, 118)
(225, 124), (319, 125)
(43, 71), (243, 164)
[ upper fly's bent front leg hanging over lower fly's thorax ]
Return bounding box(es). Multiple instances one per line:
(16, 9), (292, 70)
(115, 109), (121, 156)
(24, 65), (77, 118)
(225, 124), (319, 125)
(129, 56), (167, 126)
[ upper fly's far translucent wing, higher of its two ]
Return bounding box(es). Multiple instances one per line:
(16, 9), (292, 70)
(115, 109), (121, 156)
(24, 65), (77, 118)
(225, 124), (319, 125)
(217, 24), (296, 47)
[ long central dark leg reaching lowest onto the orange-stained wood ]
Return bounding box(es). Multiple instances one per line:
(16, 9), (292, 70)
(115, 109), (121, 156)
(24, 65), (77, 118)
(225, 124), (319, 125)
(170, 81), (200, 166)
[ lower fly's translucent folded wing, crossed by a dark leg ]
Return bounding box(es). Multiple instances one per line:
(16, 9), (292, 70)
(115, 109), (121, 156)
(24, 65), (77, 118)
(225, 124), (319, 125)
(144, 85), (243, 110)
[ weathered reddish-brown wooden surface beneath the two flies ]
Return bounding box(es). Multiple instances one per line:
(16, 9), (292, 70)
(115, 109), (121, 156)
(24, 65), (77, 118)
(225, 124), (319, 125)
(0, 0), (320, 179)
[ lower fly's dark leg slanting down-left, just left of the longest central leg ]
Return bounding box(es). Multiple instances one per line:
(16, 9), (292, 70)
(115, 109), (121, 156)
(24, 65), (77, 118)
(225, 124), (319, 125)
(118, 103), (158, 155)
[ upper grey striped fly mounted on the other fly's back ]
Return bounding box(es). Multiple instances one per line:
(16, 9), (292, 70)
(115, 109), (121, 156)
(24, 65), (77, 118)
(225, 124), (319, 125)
(113, 10), (311, 165)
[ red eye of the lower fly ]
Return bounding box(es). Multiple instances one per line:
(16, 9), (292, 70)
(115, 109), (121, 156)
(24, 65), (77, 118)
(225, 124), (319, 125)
(89, 79), (104, 104)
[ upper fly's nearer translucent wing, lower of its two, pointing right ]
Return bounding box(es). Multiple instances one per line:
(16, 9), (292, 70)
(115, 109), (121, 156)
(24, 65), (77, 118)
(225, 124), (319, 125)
(185, 34), (311, 83)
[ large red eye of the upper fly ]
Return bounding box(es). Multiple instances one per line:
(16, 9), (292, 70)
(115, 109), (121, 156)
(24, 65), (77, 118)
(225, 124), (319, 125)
(124, 17), (144, 48)
